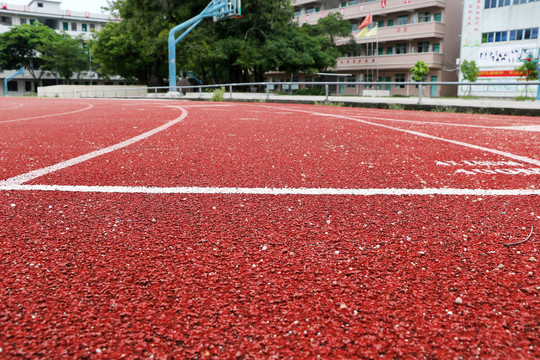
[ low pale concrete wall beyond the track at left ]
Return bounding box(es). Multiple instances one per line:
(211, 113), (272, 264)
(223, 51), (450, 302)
(38, 85), (148, 99)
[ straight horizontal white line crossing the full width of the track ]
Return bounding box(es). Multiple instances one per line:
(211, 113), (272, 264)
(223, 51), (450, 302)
(0, 184), (540, 196)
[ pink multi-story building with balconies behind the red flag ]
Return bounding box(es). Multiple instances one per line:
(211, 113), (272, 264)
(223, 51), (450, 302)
(272, 0), (463, 96)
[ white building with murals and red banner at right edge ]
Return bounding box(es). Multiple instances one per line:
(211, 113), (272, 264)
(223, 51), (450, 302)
(459, 0), (540, 97)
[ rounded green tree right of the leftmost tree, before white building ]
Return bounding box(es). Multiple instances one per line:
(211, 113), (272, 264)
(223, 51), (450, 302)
(38, 33), (89, 84)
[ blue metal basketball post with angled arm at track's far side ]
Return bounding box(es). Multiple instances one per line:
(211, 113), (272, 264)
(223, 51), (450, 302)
(169, 0), (234, 92)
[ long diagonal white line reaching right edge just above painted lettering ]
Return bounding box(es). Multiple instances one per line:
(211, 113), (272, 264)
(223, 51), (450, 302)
(267, 106), (540, 166)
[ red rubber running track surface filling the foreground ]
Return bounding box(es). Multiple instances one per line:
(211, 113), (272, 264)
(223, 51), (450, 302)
(0, 98), (540, 359)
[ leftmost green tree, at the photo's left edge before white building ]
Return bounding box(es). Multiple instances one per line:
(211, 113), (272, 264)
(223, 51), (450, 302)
(0, 23), (60, 85)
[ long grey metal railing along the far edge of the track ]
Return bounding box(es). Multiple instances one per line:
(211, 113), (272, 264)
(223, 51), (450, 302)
(75, 81), (540, 104)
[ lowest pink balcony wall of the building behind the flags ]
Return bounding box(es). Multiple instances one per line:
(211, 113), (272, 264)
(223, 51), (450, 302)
(336, 53), (444, 71)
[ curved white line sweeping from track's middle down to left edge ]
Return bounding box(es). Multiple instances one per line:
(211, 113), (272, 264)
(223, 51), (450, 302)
(0, 108), (188, 186)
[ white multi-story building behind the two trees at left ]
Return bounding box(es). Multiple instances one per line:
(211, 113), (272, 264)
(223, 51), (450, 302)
(0, 0), (121, 95)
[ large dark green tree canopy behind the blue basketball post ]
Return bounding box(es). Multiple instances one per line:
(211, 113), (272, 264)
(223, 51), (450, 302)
(92, 0), (350, 86)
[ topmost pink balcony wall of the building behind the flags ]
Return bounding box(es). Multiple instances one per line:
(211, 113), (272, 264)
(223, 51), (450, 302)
(294, 0), (447, 25)
